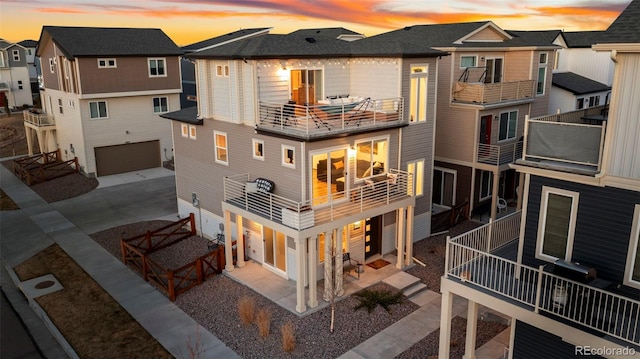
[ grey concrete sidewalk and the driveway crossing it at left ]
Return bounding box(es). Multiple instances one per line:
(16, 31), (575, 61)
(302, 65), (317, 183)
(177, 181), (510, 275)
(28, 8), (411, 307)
(0, 166), (238, 358)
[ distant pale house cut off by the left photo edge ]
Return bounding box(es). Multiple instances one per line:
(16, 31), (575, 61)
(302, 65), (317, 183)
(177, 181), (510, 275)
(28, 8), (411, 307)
(0, 39), (33, 111)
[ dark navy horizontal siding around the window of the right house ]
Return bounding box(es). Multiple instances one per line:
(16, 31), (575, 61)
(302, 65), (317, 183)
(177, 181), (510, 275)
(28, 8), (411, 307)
(523, 176), (640, 294)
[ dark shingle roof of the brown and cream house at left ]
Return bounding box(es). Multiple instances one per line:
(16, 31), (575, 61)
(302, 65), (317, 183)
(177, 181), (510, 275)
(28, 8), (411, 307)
(40, 26), (183, 58)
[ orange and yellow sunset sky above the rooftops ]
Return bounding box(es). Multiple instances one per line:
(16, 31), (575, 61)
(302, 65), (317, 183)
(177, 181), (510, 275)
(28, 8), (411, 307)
(0, 0), (630, 46)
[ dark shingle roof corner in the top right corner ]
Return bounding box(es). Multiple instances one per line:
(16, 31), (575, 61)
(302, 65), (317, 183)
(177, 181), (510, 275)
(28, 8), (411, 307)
(598, 0), (640, 44)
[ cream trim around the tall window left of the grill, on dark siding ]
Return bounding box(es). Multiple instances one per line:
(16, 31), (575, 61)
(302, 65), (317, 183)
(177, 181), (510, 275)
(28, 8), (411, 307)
(536, 186), (580, 262)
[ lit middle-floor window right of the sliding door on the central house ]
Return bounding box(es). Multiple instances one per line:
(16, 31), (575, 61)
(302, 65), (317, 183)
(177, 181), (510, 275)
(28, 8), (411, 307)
(355, 136), (389, 180)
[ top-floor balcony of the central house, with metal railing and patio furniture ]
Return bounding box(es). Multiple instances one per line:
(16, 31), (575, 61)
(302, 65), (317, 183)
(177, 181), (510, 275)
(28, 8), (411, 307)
(256, 97), (408, 141)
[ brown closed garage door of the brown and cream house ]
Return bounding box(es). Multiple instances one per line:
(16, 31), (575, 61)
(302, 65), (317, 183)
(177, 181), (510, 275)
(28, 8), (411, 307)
(95, 140), (161, 176)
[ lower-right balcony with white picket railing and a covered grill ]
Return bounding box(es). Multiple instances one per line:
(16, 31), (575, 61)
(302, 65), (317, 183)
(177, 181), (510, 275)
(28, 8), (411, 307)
(443, 212), (640, 346)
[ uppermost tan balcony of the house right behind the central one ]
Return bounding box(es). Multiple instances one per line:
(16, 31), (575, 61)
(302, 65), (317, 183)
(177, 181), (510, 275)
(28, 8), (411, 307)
(452, 80), (536, 107)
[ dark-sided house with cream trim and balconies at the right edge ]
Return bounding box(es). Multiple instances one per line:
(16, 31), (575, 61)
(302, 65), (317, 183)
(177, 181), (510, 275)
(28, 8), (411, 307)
(439, 0), (640, 359)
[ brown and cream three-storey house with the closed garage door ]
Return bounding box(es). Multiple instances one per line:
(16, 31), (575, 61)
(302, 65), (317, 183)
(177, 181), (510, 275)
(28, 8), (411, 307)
(32, 26), (182, 176)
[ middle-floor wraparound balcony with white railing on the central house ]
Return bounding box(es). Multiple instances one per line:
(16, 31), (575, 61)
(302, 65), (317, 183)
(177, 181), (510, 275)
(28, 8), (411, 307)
(224, 169), (415, 235)
